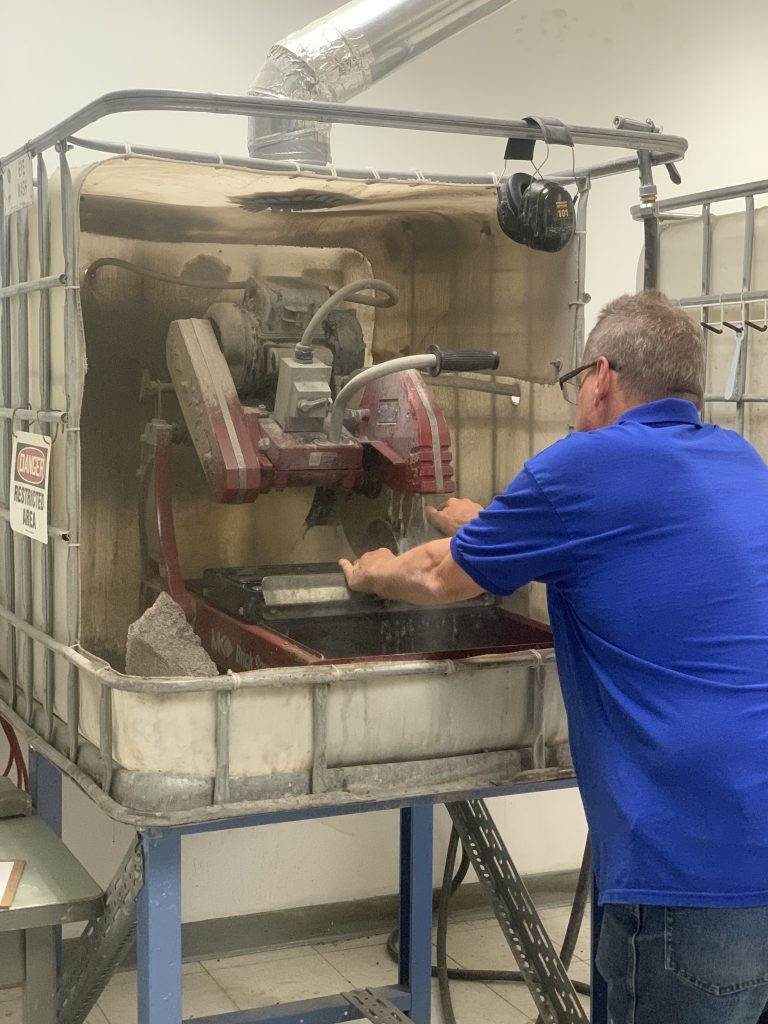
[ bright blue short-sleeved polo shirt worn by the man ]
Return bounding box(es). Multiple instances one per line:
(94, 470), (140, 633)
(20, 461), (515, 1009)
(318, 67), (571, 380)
(452, 398), (768, 906)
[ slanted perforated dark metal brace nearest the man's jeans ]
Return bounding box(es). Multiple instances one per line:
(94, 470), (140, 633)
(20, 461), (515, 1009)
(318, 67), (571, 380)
(445, 800), (589, 1024)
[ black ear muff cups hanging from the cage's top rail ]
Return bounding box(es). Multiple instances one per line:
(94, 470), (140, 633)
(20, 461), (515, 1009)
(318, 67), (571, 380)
(497, 174), (575, 253)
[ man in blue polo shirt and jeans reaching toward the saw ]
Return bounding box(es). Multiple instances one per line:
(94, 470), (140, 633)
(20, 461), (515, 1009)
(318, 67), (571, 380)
(341, 292), (768, 1024)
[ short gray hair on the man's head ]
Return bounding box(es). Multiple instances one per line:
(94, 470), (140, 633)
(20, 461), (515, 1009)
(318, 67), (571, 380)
(583, 290), (705, 406)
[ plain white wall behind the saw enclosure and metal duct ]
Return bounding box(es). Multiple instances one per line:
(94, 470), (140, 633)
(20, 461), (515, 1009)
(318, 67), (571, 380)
(0, 0), (768, 920)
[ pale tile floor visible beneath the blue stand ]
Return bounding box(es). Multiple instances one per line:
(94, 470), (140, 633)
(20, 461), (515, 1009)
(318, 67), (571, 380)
(0, 907), (589, 1024)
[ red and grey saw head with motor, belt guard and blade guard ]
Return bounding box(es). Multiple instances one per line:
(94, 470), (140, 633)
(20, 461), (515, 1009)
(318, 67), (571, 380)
(166, 278), (455, 503)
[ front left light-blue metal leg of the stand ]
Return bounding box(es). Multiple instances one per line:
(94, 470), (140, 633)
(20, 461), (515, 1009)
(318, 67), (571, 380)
(136, 829), (181, 1024)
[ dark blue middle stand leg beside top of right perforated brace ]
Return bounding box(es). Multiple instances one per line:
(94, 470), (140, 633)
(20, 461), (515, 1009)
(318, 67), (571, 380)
(397, 804), (433, 1024)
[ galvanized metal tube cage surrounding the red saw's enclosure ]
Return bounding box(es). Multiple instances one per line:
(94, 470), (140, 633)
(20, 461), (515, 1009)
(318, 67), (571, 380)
(0, 90), (688, 826)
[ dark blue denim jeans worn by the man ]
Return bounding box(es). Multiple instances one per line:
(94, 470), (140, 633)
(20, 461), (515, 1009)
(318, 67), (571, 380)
(595, 904), (768, 1024)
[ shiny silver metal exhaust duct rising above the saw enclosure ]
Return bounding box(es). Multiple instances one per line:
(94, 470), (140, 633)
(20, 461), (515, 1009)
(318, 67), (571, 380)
(248, 0), (520, 164)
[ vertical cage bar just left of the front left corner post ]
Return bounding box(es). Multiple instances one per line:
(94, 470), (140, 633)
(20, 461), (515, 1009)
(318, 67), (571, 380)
(37, 154), (55, 739)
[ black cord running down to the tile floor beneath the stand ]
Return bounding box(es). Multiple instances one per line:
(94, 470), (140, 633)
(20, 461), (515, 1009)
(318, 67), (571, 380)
(386, 828), (592, 1024)
